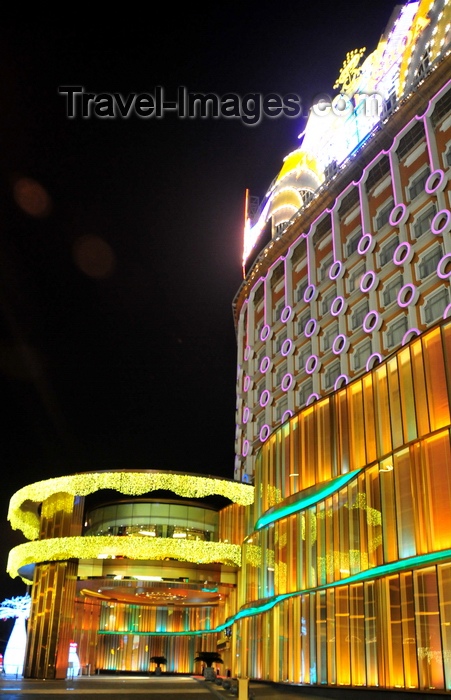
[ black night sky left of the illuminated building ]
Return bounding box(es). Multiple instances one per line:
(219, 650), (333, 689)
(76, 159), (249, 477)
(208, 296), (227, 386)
(0, 0), (400, 608)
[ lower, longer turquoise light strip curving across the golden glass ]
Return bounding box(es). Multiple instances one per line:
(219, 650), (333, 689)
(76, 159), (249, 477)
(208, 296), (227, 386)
(97, 549), (451, 637)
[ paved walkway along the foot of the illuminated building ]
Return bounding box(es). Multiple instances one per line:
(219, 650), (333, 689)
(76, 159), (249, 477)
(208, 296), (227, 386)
(0, 674), (451, 700)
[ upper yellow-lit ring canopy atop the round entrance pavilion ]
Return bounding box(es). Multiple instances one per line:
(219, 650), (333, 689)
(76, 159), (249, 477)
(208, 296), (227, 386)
(8, 469), (254, 540)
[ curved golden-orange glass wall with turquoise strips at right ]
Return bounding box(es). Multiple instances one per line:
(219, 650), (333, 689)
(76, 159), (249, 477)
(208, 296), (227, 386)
(241, 321), (451, 690)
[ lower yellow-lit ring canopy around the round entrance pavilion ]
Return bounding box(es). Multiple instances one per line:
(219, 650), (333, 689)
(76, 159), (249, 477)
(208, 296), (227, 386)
(7, 535), (241, 583)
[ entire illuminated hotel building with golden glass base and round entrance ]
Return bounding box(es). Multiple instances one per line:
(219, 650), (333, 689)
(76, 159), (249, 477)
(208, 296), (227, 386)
(8, 0), (451, 692)
